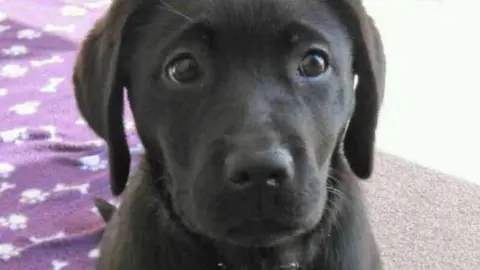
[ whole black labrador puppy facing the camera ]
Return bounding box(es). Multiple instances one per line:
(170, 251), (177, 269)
(73, 0), (385, 270)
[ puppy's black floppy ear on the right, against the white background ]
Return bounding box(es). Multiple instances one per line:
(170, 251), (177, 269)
(329, 0), (386, 179)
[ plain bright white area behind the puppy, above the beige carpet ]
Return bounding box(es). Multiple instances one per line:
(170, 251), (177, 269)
(366, 0), (480, 184)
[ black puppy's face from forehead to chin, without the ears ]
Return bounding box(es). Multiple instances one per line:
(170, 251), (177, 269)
(128, 0), (354, 246)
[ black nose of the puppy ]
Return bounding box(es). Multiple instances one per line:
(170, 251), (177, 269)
(225, 148), (294, 188)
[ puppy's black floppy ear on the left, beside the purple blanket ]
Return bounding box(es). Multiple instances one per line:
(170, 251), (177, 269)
(73, 0), (139, 195)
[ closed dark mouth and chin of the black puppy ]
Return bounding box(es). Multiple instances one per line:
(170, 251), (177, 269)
(225, 217), (299, 246)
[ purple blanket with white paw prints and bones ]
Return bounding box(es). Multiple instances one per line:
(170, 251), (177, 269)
(0, 0), (142, 270)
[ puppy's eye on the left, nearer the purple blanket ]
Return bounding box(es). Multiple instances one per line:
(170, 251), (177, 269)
(167, 55), (202, 84)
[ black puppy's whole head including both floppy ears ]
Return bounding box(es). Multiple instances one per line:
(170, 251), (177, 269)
(74, 0), (385, 246)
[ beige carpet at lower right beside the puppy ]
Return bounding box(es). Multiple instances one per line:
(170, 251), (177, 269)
(364, 153), (480, 270)
